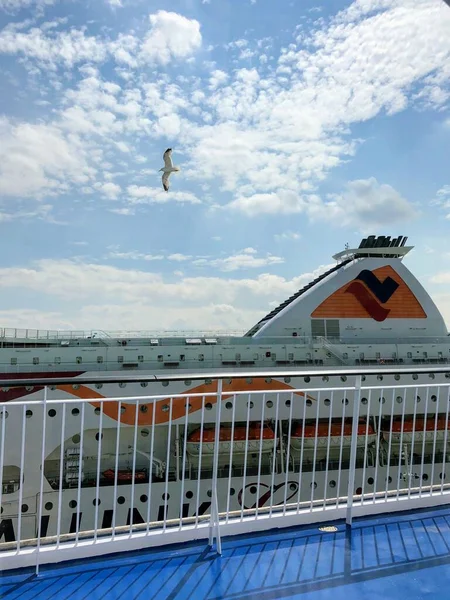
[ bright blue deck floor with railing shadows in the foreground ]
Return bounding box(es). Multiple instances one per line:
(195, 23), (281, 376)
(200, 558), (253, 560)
(0, 507), (450, 600)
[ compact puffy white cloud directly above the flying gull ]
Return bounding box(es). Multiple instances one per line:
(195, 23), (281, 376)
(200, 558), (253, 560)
(140, 10), (202, 65)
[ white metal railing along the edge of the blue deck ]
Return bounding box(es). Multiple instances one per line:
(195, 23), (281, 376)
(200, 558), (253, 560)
(0, 367), (450, 569)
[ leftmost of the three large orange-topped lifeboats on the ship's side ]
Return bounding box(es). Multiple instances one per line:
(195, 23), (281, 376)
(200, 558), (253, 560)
(186, 423), (275, 456)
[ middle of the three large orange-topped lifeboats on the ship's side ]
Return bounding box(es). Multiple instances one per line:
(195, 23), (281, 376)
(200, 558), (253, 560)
(291, 419), (376, 450)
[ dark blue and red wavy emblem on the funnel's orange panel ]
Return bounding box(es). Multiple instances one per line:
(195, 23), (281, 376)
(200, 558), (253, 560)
(346, 269), (399, 322)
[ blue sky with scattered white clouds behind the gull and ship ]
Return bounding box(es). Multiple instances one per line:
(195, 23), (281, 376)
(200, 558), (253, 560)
(0, 0), (450, 332)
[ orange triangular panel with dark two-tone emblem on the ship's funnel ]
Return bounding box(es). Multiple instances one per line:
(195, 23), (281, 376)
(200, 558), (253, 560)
(311, 265), (427, 323)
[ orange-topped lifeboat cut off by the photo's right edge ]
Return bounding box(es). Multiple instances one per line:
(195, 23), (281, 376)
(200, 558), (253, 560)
(381, 415), (450, 444)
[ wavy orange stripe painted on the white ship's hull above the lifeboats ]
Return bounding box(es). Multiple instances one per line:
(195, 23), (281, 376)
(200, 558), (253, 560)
(58, 378), (315, 426)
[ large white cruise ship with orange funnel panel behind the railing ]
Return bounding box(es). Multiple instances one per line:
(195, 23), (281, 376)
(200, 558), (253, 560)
(0, 236), (450, 543)
